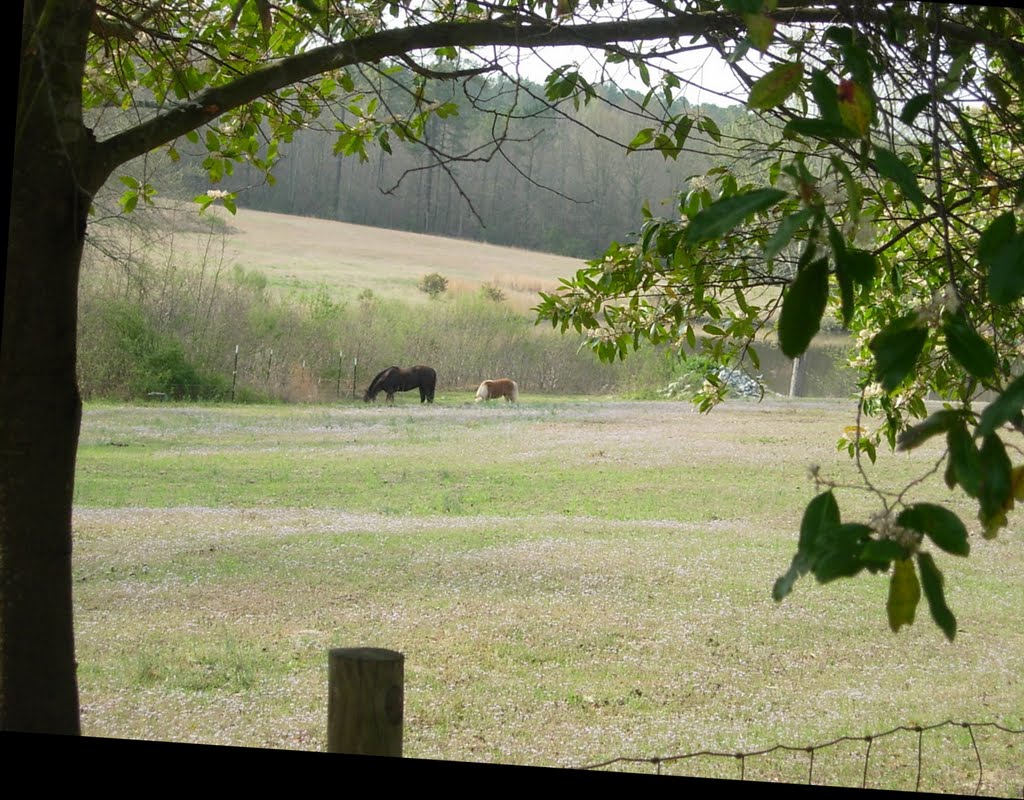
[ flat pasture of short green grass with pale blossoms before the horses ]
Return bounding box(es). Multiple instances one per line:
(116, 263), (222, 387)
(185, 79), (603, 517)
(74, 393), (1024, 796)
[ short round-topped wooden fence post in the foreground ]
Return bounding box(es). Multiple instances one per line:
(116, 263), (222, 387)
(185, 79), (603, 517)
(327, 647), (406, 757)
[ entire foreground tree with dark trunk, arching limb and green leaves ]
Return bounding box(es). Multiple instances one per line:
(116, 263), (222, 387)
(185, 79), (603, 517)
(8, 0), (1024, 732)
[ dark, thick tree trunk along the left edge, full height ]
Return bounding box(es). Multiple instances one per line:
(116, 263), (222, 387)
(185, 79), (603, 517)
(0, 0), (102, 733)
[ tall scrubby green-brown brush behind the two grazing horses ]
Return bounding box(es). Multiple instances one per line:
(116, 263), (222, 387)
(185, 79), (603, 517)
(79, 246), (675, 403)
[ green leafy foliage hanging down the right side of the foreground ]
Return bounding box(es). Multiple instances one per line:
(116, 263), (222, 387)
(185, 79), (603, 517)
(540, 2), (1024, 639)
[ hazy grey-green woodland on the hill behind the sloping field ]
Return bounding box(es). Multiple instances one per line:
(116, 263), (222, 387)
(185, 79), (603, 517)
(163, 72), (750, 257)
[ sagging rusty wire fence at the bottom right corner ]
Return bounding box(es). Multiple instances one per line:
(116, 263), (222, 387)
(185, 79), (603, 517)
(582, 720), (1024, 798)
